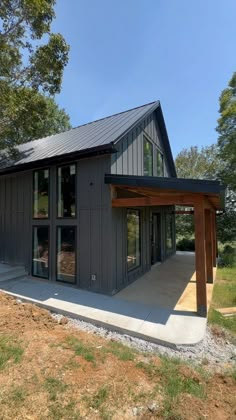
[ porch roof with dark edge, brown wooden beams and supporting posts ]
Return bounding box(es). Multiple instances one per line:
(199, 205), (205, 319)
(105, 174), (225, 317)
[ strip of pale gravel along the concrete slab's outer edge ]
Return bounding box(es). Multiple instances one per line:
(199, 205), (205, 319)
(52, 313), (236, 370)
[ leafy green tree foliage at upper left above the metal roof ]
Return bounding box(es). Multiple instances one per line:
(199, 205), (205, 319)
(0, 0), (70, 149)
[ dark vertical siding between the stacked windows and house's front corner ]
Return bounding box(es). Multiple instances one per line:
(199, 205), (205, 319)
(78, 156), (112, 293)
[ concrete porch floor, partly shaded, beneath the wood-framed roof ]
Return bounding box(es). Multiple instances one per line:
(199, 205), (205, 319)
(114, 252), (216, 312)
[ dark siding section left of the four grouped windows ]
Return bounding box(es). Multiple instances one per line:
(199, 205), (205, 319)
(0, 172), (32, 267)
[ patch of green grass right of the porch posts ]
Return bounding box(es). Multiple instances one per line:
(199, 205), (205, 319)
(208, 267), (236, 335)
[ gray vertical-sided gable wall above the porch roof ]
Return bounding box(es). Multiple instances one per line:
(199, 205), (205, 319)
(111, 112), (170, 177)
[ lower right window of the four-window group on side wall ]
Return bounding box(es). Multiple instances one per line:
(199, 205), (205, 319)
(57, 226), (76, 283)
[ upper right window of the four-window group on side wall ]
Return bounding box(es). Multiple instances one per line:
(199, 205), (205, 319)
(57, 165), (76, 217)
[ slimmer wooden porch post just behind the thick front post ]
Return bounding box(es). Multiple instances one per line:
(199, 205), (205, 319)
(205, 209), (213, 283)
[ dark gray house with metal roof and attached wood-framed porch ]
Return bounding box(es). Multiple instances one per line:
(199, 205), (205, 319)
(0, 101), (224, 314)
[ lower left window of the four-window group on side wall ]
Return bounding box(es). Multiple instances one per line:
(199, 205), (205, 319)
(33, 226), (49, 278)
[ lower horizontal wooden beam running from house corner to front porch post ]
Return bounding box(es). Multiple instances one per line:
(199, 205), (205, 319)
(112, 194), (196, 207)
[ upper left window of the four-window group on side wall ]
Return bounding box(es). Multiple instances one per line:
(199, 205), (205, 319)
(33, 169), (49, 219)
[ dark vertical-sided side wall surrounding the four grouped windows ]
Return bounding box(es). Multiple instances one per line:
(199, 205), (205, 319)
(0, 155), (112, 293)
